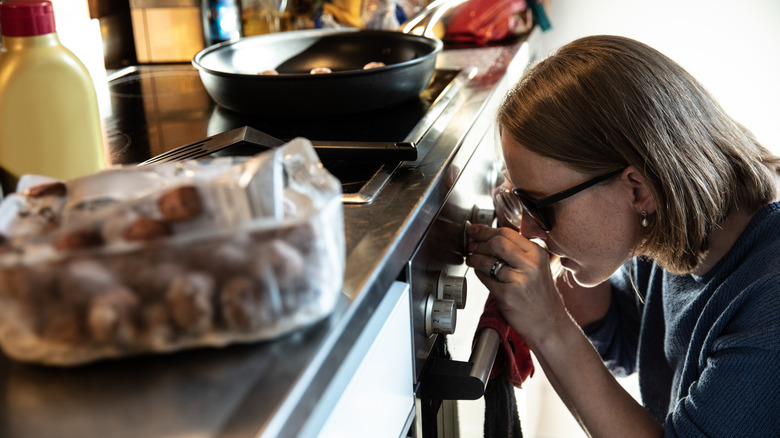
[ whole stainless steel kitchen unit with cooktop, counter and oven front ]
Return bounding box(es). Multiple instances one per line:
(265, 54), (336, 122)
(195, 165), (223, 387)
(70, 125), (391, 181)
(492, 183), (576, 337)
(0, 31), (533, 438)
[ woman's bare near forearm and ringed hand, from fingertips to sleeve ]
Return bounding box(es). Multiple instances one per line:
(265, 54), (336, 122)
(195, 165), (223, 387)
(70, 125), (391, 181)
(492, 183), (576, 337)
(466, 225), (663, 437)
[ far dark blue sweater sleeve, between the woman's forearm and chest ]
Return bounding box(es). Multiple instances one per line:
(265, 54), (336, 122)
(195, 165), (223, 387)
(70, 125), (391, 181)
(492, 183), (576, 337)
(583, 261), (641, 377)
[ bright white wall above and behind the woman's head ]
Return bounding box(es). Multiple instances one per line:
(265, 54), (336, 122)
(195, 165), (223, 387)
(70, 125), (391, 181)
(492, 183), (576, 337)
(542, 0), (780, 154)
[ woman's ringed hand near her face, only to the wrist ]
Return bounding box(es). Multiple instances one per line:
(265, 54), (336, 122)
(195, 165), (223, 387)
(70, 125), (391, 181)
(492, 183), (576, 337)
(466, 225), (571, 349)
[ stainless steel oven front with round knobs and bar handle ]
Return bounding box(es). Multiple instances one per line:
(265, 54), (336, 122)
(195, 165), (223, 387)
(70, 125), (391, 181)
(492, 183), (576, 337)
(409, 121), (501, 438)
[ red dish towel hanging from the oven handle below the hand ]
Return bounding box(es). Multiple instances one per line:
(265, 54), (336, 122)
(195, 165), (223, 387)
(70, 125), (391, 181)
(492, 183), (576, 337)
(476, 295), (534, 388)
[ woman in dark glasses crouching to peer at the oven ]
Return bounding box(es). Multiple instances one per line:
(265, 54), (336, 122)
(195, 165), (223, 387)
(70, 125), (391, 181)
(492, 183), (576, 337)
(467, 36), (780, 437)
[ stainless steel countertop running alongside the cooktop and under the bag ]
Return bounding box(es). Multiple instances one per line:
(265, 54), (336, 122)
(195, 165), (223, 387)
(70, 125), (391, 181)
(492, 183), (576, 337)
(0, 31), (536, 438)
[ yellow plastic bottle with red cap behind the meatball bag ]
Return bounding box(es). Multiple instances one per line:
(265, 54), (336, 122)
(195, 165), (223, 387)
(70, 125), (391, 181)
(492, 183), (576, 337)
(0, 0), (104, 193)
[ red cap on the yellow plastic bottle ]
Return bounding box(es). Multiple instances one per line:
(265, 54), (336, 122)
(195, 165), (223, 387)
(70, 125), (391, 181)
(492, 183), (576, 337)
(0, 0), (56, 37)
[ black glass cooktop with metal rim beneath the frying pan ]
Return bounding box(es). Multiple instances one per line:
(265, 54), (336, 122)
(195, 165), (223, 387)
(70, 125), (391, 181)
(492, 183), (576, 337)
(105, 64), (468, 203)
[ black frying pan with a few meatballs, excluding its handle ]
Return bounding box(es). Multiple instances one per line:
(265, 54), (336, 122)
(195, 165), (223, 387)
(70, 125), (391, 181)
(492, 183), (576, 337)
(192, 29), (443, 115)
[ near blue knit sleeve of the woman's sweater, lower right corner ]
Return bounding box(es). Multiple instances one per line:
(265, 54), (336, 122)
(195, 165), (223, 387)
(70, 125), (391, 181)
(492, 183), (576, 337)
(665, 278), (780, 437)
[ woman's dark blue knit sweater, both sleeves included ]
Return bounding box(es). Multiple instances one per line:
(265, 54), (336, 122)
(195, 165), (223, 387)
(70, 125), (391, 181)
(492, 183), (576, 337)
(584, 203), (780, 437)
